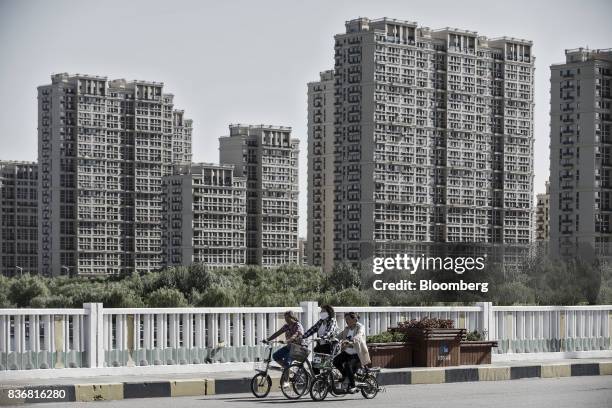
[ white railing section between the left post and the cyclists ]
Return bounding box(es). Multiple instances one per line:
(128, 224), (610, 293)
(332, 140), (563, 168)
(103, 307), (304, 366)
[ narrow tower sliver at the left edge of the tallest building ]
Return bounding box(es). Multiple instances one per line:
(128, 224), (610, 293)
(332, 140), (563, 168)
(306, 70), (335, 270)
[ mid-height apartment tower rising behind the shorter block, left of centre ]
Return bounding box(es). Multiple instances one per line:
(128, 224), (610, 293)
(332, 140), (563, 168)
(219, 125), (299, 267)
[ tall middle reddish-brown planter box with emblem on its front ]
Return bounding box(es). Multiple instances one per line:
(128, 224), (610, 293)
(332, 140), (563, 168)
(391, 328), (466, 367)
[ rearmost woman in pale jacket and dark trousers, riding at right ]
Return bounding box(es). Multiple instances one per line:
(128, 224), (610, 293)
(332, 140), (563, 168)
(334, 312), (370, 394)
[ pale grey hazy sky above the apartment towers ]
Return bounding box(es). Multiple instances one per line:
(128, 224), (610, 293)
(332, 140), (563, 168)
(0, 0), (612, 236)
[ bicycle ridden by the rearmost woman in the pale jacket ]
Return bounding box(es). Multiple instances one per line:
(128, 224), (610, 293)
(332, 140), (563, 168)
(310, 356), (381, 401)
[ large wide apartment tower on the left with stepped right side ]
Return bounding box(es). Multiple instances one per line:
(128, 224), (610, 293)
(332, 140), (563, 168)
(38, 74), (191, 275)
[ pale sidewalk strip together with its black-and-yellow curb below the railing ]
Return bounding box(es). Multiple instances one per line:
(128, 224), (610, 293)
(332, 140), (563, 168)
(0, 358), (612, 405)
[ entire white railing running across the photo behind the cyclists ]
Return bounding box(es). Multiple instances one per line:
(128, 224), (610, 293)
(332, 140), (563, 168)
(0, 302), (612, 370)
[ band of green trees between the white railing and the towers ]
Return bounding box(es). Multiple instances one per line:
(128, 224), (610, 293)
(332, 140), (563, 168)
(0, 254), (612, 308)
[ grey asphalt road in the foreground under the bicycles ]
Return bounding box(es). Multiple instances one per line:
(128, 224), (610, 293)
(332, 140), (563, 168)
(23, 376), (612, 408)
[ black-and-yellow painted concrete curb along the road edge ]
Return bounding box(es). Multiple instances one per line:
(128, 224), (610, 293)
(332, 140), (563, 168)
(0, 362), (612, 405)
